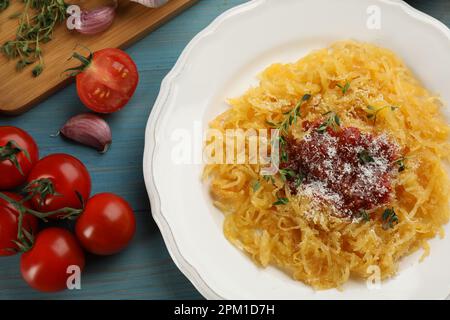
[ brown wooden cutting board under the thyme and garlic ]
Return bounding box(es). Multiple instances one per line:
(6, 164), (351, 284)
(0, 0), (197, 115)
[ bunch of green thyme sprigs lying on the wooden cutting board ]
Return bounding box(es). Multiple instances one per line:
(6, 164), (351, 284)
(0, 0), (67, 77)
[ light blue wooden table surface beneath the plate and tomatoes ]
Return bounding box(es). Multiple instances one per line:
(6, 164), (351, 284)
(0, 0), (450, 299)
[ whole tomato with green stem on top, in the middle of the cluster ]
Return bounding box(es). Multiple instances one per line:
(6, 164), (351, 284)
(27, 153), (91, 212)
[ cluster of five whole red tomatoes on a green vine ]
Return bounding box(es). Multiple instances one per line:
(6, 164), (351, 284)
(0, 127), (136, 292)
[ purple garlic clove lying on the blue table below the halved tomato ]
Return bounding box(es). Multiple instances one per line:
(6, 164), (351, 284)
(60, 113), (112, 153)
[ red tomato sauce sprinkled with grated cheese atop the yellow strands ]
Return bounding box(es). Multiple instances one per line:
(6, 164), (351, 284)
(280, 122), (399, 217)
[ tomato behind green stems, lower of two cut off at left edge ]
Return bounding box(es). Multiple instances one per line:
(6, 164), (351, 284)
(0, 192), (38, 256)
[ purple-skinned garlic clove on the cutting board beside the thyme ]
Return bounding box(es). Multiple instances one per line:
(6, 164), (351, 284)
(75, 6), (116, 35)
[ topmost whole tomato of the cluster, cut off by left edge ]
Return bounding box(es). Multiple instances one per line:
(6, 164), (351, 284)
(0, 126), (39, 190)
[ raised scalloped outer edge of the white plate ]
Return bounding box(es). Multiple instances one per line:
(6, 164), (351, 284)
(143, 0), (450, 300)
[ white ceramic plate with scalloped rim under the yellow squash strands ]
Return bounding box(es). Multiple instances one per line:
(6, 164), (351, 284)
(144, 0), (450, 299)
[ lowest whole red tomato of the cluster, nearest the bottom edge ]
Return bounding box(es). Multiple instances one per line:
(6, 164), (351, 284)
(20, 228), (85, 292)
